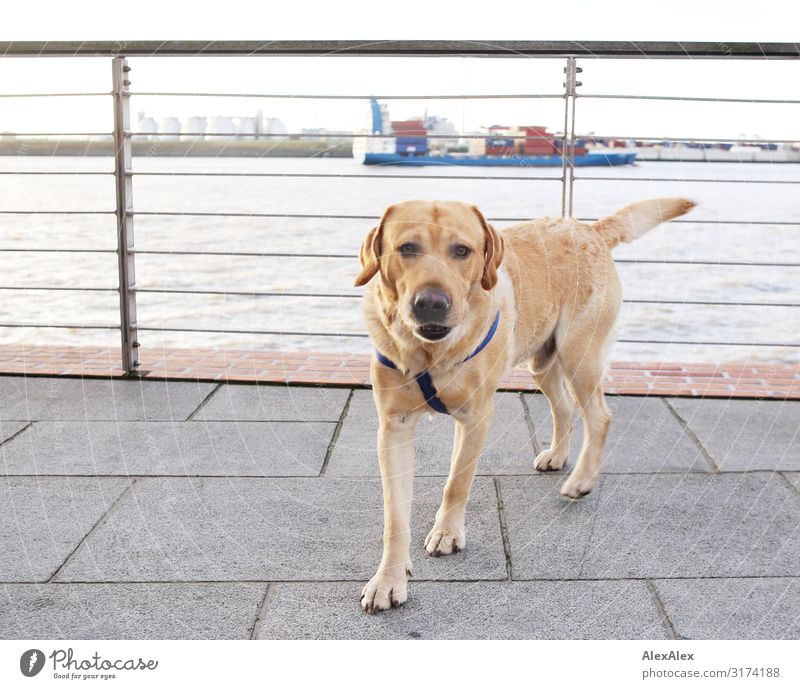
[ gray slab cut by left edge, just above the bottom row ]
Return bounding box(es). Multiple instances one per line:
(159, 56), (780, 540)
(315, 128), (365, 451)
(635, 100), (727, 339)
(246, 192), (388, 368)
(0, 477), (130, 582)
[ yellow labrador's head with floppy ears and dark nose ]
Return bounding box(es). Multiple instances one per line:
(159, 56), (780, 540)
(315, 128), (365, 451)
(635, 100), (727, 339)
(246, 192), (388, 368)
(355, 201), (503, 342)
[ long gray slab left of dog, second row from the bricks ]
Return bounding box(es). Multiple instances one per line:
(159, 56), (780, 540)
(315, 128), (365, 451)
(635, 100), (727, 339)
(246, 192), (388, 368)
(0, 421), (335, 476)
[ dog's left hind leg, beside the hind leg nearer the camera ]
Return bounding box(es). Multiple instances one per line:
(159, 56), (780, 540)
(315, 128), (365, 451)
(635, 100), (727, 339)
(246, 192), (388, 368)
(528, 344), (575, 471)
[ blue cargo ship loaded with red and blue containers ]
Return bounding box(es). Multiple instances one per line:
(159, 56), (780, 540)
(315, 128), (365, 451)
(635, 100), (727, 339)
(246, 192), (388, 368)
(353, 98), (636, 167)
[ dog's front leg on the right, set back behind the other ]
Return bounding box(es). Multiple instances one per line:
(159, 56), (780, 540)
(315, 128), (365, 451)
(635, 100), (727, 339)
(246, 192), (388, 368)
(425, 400), (492, 557)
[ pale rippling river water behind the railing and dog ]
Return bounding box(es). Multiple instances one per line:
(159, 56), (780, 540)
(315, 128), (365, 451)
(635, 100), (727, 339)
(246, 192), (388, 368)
(0, 156), (800, 361)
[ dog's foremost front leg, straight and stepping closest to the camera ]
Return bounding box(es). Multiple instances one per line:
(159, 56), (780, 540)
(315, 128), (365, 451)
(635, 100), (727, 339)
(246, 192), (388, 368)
(361, 414), (418, 613)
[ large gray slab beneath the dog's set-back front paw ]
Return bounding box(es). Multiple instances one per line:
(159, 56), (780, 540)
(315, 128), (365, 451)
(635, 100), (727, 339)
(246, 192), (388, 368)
(58, 478), (506, 581)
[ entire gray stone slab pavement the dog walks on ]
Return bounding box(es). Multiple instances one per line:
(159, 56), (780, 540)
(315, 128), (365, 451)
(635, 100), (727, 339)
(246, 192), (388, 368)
(0, 376), (800, 639)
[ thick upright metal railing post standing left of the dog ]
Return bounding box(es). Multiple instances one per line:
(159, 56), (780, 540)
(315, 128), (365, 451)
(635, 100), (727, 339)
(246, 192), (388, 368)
(111, 57), (139, 374)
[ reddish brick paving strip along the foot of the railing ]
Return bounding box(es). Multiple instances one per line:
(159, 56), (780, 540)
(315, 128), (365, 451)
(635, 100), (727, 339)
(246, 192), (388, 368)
(0, 345), (800, 399)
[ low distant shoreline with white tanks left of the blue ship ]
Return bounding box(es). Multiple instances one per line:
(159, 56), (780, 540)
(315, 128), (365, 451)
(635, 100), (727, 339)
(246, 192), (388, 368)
(0, 137), (353, 158)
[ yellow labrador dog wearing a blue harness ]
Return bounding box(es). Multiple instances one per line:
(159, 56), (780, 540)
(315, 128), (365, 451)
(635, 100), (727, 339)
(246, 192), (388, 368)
(355, 198), (695, 612)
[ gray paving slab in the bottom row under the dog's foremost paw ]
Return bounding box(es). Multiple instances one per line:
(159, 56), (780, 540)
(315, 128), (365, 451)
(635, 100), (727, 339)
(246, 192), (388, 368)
(257, 580), (666, 639)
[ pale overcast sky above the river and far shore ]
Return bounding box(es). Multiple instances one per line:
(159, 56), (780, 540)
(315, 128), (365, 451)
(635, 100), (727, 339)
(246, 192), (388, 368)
(0, 0), (800, 139)
